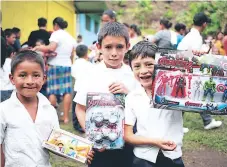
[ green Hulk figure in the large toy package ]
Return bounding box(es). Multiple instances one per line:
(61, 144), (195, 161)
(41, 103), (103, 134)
(203, 77), (216, 102)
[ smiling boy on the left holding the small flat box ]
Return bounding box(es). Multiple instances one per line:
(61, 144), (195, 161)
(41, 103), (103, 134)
(0, 51), (59, 167)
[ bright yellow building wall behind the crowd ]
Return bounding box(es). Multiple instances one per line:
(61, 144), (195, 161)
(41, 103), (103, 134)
(1, 0), (76, 43)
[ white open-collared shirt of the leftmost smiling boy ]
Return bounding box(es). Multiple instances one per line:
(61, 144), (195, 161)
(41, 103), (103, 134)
(0, 91), (59, 167)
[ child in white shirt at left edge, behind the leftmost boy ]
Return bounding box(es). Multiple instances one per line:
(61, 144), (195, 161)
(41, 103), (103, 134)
(0, 46), (15, 102)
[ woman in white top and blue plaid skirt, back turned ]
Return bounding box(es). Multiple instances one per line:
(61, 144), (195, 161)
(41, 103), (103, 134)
(33, 17), (76, 123)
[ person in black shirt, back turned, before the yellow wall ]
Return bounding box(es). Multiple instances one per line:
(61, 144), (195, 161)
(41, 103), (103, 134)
(28, 17), (50, 47)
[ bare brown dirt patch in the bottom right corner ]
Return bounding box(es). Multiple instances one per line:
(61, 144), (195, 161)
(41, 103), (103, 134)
(183, 147), (227, 167)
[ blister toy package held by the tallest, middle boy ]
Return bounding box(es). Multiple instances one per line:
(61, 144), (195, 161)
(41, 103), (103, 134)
(86, 93), (125, 149)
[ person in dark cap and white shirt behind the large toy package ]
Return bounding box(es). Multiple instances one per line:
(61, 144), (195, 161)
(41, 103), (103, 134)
(177, 12), (222, 132)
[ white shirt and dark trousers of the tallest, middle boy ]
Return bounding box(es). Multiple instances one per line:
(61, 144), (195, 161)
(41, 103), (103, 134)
(74, 62), (139, 167)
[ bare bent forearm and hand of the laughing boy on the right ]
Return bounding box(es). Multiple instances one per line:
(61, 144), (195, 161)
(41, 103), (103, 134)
(124, 125), (176, 151)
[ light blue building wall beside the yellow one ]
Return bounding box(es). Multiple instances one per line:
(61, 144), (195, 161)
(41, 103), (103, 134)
(77, 14), (100, 46)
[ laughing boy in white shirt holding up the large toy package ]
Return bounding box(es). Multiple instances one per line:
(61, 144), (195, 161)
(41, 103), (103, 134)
(125, 41), (184, 167)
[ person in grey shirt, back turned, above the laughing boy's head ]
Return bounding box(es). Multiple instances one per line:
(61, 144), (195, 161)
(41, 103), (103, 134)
(152, 19), (173, 49)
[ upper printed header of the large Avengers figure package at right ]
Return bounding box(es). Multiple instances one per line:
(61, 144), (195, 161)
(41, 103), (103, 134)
(155, 49), (227, 76)
